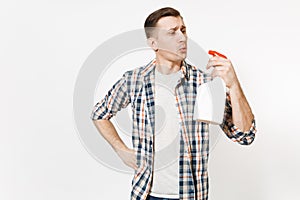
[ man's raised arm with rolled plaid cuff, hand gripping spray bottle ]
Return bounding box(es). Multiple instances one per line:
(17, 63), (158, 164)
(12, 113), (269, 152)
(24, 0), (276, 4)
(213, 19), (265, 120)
(207, 56), (256, 145)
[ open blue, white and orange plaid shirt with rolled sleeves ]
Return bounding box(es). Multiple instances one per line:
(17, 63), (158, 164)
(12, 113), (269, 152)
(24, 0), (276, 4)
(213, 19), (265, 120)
(91, 60), (256, 200)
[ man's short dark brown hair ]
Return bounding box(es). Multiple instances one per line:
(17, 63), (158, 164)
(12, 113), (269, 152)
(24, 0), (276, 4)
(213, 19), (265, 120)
(144, 7), (182, 38)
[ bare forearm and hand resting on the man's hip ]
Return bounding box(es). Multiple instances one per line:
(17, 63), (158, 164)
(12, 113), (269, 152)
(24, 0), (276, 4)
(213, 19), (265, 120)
(93, 119), (137, 170)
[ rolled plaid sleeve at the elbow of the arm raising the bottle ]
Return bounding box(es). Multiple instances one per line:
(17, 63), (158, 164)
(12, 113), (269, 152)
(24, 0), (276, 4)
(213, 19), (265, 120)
(220, 92), (256, 145)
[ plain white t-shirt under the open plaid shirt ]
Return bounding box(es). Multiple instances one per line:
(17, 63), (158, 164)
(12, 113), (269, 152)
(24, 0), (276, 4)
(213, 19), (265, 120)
(150, 68), (182, 198)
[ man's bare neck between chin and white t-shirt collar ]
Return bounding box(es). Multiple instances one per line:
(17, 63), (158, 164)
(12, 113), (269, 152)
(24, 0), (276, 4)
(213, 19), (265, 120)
(156, 57), (182, 74)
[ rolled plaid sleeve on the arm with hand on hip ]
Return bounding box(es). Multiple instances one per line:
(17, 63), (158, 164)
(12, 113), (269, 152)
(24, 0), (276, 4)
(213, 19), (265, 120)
(90, 73), (130, 120)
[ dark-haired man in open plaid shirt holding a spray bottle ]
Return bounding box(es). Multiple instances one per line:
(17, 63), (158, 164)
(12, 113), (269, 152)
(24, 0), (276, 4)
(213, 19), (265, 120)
(91, 7), (256, 200)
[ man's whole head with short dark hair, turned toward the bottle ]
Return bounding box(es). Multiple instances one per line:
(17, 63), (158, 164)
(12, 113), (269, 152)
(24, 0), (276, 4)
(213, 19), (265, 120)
(144, 7), (187, 61)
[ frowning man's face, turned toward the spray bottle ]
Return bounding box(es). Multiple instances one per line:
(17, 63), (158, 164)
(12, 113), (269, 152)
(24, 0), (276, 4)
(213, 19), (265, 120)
(154, 16), (187, 62)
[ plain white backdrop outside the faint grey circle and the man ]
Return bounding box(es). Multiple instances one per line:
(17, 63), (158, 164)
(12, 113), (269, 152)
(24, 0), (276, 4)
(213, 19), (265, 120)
(0, 0), (300, 200)
